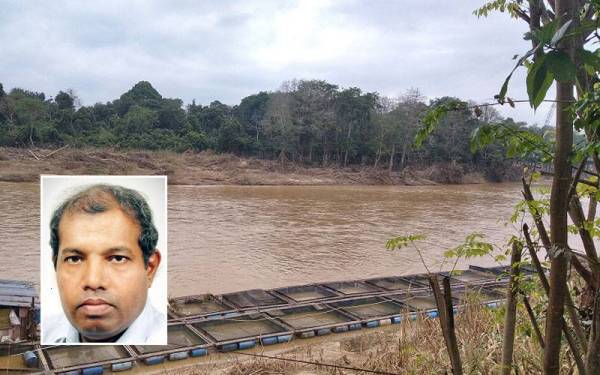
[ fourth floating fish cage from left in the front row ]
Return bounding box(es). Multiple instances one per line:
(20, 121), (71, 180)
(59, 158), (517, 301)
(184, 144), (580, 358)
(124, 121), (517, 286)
(268, 304), (360, 338)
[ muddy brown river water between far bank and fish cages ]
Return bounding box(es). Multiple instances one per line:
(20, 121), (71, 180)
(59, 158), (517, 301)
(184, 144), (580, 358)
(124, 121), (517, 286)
(0, 182), (520, 296)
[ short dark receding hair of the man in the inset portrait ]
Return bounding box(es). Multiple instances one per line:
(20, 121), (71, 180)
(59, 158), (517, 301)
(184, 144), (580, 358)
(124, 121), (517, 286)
(50, 184), (158, 268)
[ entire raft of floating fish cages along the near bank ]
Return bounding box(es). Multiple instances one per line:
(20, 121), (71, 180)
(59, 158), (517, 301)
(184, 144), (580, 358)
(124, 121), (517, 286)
(0, 266), (516, 375)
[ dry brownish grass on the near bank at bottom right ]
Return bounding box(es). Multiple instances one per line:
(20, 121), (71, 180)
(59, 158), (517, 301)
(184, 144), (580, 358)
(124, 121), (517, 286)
(174, 303), (574, 375)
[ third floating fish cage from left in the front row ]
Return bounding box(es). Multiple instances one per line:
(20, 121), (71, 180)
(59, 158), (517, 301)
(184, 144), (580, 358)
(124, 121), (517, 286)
(192, 314), (291, 351)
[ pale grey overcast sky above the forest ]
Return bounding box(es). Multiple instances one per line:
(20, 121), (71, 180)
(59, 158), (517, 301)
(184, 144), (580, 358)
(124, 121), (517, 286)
(0, 0), (553, 124)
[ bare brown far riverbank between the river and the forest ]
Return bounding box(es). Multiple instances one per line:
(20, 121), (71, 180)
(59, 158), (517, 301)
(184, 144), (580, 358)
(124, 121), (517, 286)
(0, 148), (516, 186)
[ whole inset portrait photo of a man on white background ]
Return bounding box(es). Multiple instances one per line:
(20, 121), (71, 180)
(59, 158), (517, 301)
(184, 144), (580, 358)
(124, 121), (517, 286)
(40, 176), (167, 345)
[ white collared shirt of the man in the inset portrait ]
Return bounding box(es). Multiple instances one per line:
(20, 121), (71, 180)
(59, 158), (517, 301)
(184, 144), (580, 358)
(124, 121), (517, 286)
(42, 300), (167, 345)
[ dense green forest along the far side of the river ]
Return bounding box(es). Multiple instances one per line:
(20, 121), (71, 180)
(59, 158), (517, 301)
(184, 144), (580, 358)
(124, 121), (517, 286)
(0, 80), (544, 180)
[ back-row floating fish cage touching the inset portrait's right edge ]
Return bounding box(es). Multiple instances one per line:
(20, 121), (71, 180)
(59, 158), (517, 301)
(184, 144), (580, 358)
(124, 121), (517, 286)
(169, 294), (236, 317)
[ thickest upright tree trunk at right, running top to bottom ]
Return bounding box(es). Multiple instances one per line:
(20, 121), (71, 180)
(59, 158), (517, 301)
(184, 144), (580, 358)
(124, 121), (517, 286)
(544, 0), (575, 374)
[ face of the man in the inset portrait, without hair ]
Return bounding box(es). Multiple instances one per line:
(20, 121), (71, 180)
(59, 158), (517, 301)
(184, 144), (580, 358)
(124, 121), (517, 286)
(56, 208), (160, 341)
